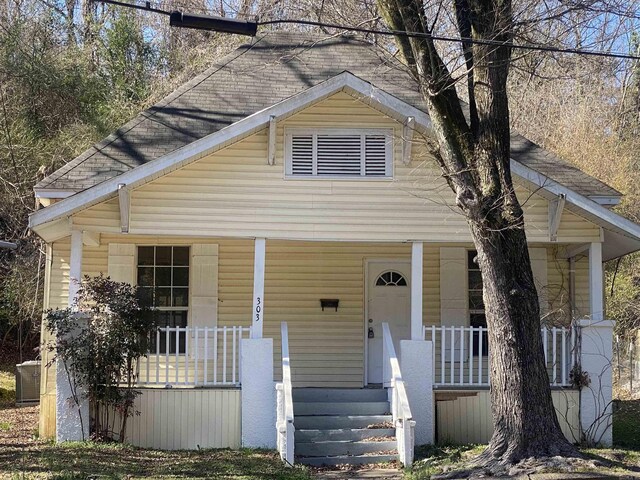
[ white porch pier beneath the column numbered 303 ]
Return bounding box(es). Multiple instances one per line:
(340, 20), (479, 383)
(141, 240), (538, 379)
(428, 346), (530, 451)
(240, 338), (277, 448)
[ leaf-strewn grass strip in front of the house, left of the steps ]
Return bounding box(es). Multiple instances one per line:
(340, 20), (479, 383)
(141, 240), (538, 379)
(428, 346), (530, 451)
(0, 443), (312, 480)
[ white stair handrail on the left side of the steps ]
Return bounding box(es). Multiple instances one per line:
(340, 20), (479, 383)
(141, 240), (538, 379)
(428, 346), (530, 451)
(276, 322), (295, 465)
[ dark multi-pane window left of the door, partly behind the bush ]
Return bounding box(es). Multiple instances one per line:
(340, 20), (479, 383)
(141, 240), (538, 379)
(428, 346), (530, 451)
(138, 247), (189, 353)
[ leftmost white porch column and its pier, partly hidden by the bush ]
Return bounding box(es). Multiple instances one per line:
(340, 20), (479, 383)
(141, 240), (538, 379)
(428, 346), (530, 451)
(56, 230), (89, 442)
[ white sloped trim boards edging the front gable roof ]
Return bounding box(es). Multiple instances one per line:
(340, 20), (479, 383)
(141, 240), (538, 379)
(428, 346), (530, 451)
(29, 71), (640, 256)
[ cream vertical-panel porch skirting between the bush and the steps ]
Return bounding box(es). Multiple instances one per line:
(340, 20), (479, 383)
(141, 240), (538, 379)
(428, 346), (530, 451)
(126, 389), (241, 450)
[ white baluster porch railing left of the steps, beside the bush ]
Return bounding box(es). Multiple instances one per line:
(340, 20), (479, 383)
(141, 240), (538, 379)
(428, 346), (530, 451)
(137, 326), (251, 387)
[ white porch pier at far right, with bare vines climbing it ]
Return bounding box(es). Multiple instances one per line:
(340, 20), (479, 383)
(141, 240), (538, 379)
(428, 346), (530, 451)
(580, 319), (615, 446)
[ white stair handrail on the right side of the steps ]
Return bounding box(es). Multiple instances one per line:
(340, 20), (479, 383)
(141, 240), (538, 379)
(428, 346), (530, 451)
(382, 322), (416, 467)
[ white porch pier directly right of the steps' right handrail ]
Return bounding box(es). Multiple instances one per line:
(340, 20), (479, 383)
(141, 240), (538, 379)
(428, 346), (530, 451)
(400, 340), (435, 445)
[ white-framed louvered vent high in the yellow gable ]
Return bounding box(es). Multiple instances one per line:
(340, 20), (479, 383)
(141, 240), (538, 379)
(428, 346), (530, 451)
(286, 129), (393, 178)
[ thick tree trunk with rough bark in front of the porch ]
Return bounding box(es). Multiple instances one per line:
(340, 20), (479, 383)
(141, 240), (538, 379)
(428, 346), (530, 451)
(378, 0), (580, 469)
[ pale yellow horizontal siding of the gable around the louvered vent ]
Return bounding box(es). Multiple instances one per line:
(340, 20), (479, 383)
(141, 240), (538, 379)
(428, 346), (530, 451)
(73, 93), (599, 242)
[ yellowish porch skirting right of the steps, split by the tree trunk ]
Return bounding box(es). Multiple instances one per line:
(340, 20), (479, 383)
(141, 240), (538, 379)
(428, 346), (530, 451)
(436, 390), (580, 444)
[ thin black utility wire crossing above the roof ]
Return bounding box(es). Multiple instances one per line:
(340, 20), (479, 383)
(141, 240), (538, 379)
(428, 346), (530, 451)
(91, 0), (640, 60)
